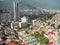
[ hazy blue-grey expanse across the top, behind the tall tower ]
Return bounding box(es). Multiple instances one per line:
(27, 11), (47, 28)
(0, 0), (60, 10)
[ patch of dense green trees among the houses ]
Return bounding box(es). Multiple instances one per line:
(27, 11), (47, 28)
(31, 32), (49, 45)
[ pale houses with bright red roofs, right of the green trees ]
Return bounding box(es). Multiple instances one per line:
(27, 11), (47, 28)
(25, 25), (60, 45)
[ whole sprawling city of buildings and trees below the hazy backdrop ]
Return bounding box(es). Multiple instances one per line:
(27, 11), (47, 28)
(0, 9), (60, 45)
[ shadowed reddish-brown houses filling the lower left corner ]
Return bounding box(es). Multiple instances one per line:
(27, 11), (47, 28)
(0, 25), (28, 45)
